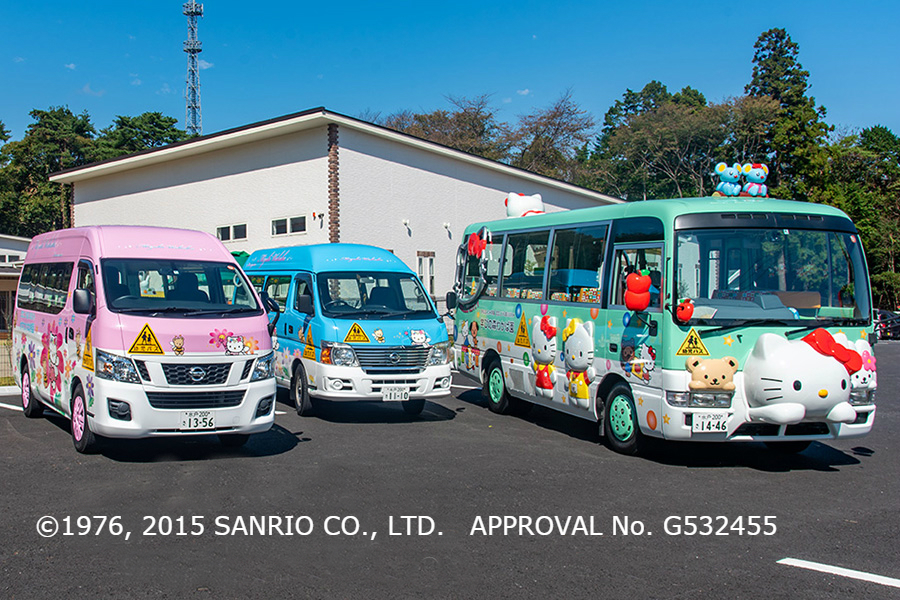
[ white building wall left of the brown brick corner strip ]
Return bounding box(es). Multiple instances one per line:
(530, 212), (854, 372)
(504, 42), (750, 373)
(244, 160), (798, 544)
(75, 128), (328, 252)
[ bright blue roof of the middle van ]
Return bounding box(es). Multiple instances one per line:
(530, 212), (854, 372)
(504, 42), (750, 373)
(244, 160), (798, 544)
(244, 244), (413, 273)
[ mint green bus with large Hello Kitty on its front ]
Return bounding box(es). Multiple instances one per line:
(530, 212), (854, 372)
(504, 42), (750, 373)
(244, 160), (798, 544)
(447, 197), (876, 454)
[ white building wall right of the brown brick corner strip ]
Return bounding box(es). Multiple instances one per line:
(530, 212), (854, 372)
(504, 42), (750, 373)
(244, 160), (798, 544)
(340, 127), (612, 299)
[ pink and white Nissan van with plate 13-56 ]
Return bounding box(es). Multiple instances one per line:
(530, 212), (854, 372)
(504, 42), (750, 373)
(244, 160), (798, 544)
(13, 226), (275, 452)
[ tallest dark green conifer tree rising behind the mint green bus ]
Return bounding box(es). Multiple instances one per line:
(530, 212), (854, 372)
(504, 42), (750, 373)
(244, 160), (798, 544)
(745, 28), (830, 200)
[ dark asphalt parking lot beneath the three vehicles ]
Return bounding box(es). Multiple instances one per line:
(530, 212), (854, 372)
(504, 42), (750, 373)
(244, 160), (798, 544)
(0, 342), (900, 598)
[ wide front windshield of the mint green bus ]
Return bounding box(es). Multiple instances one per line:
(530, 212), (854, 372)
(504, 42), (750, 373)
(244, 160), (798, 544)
(673, 228), (871, 327)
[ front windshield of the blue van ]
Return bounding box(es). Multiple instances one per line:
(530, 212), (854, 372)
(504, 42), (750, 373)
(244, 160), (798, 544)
(316, 271), (437, 319)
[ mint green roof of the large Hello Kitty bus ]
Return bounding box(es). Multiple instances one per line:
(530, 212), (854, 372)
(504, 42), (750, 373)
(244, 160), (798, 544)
(466, 196), (849, 234)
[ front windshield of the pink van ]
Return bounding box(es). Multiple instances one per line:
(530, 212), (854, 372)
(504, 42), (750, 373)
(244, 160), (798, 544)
(101, 258), (262, 318)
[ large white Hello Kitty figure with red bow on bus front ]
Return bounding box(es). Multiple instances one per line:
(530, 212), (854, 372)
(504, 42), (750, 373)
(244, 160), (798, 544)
(744, 329), (863, 425)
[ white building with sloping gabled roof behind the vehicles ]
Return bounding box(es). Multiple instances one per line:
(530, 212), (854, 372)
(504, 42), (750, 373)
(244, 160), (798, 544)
(50, 108), (620, 298)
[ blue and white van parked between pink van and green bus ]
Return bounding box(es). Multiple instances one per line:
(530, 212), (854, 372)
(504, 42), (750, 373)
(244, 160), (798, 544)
(244, 244), (450, 415)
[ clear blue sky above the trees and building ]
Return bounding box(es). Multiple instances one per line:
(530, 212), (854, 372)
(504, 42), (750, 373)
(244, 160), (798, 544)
(0, 0), (900, 139)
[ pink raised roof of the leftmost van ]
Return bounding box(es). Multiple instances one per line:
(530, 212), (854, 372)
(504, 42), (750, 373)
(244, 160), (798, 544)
(26, 225), (234, 262)
